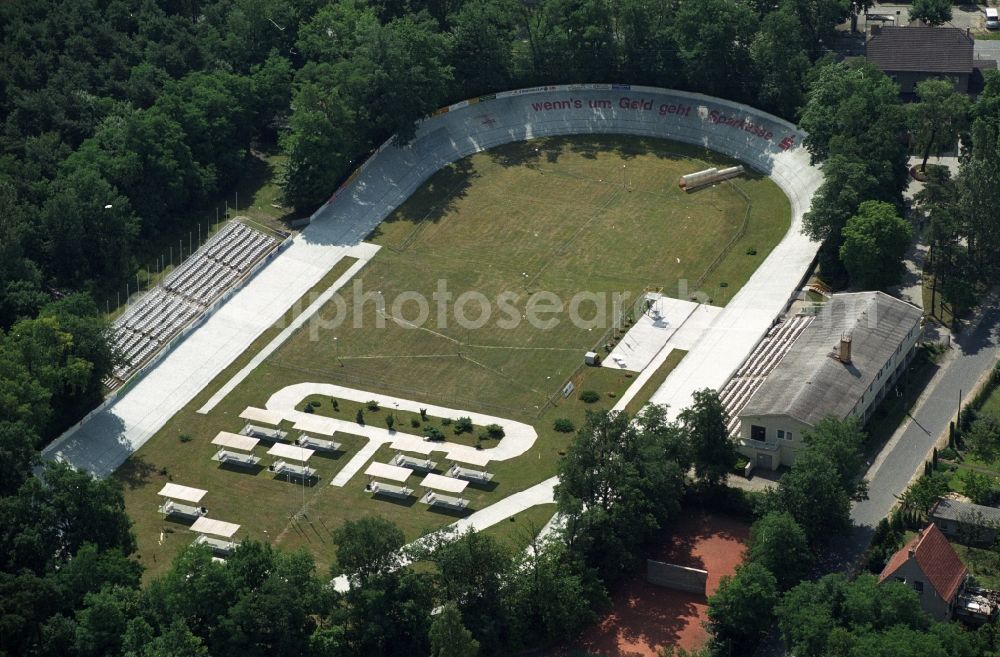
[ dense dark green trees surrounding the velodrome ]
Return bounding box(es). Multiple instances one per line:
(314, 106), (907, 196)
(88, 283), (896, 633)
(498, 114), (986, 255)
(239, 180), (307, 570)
(0, 0), (1000, 656)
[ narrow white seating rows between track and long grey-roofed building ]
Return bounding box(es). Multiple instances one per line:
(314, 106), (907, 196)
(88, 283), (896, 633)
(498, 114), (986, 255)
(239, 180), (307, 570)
(719, 316), (813, 436)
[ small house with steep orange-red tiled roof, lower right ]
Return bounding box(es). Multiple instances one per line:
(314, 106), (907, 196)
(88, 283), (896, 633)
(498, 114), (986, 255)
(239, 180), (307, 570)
(878, 523), (969, 620)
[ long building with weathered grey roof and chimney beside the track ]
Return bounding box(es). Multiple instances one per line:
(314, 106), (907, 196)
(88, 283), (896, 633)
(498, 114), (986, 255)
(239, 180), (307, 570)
(738, 292), (923, 470)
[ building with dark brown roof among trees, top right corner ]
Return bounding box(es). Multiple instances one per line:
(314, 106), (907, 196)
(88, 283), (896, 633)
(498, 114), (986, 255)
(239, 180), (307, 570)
(866, 26), (996, 95)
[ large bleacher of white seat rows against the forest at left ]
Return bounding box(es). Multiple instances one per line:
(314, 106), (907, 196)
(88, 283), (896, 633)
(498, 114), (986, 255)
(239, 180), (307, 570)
(105, 221), (280, 389)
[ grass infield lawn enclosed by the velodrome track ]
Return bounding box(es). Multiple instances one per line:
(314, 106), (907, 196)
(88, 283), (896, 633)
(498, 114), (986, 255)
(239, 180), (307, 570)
(117, 137), (789, 576)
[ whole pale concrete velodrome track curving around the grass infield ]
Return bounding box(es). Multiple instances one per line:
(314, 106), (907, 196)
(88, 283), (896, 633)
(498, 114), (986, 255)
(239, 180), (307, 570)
(43, 85), (822, 476)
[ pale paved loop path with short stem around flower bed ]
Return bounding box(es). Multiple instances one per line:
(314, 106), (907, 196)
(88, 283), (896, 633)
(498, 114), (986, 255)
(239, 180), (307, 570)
(266, 383), (538, 486)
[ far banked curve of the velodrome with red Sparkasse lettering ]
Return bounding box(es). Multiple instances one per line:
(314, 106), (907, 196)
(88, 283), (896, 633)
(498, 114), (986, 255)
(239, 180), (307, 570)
(312, 84), (822, 242)
